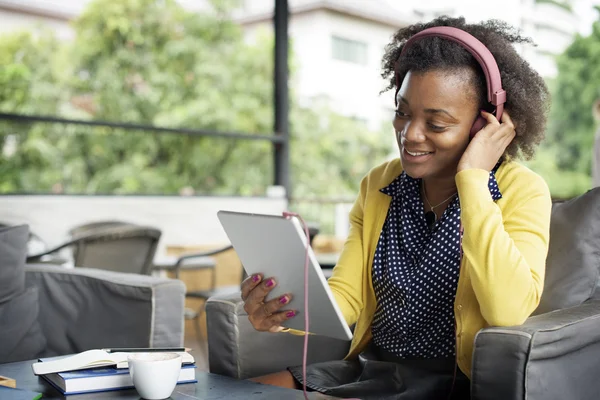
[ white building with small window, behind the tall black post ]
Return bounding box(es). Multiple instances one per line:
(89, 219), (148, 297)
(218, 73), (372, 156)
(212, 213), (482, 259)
(231, 0), (416, 129)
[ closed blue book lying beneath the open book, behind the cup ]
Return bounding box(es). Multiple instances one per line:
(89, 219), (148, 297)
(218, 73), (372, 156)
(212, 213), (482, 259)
(42, 364), (197, 395)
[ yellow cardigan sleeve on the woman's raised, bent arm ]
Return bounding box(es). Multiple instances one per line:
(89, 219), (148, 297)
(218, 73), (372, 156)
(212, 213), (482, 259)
(456, 169), (552, 326)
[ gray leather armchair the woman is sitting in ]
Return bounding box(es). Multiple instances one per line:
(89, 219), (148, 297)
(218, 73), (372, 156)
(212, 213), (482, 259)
(206, 188), (600, 400)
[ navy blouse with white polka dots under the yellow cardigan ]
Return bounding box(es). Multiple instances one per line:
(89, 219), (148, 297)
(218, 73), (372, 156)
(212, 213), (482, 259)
(372, 164), (502, 359)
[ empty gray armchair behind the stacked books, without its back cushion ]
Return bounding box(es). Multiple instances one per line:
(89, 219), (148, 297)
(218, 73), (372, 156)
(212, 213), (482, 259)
(0, 262), (185, 364)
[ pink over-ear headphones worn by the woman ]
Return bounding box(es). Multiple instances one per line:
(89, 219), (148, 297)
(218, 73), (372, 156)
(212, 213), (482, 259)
(394, 26), (506, 137)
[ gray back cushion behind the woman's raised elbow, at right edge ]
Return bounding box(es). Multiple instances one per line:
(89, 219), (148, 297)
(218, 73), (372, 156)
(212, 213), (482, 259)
(534, 188), (600, 315)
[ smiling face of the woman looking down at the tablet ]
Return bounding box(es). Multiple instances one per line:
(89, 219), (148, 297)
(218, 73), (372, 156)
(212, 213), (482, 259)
(393, 68), (479, 178)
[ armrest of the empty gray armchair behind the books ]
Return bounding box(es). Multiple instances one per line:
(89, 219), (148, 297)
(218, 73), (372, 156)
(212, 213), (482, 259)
(25, 265), (185, 356)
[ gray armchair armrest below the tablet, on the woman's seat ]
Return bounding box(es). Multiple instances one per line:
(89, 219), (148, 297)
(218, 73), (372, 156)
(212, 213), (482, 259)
(206, 292), (350, 379)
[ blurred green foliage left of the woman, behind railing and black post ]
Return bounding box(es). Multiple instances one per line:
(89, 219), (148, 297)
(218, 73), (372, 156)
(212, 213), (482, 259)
(0, 0), (390, 202)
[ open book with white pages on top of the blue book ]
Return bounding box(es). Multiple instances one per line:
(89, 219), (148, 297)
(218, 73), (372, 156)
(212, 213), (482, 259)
(31, 350), (194, 375)
